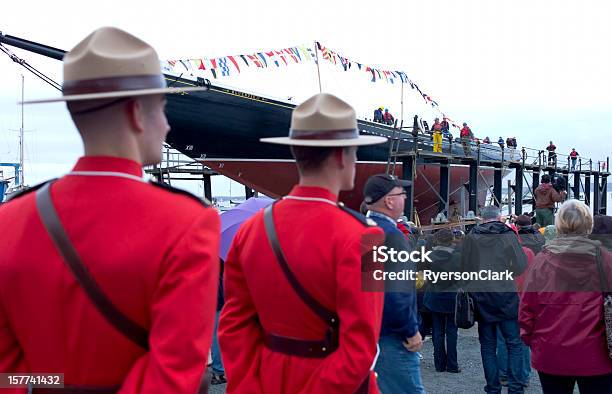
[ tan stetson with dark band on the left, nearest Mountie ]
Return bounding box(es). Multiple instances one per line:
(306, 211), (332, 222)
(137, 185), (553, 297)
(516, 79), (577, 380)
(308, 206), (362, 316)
(24, 27), (206, 104)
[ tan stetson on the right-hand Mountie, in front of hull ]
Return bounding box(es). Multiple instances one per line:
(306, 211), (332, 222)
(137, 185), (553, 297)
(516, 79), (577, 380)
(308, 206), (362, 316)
(260, 93), (387, 147)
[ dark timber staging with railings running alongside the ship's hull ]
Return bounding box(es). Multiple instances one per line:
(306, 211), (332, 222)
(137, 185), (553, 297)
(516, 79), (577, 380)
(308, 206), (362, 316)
(387, 117), (610, 222)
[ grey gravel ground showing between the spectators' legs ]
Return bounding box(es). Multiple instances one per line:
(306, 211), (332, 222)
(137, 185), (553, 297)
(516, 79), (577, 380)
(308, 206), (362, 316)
(210, 326), (542, 394)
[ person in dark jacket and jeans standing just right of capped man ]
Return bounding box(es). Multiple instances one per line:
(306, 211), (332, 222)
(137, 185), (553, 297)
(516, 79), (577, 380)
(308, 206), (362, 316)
(424, 229), (461, 373)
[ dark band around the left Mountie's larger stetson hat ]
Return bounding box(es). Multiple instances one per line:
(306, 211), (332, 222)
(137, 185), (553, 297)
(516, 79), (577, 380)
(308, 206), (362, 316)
(62, 74), (166, 96)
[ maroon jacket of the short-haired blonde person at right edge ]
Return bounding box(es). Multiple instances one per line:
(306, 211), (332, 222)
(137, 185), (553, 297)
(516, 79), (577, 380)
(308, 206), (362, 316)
(519, 241), (612, 376)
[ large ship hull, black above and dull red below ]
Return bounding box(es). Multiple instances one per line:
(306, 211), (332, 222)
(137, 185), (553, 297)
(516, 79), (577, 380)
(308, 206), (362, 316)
(167, 80), (495, 222)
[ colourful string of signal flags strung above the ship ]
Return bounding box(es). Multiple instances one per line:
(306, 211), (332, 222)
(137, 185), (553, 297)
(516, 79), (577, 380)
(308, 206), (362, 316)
(161, 41), (459, 128)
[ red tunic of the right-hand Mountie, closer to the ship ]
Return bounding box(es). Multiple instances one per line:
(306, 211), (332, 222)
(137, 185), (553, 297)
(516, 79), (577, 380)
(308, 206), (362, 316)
(219, 186), (383, 393)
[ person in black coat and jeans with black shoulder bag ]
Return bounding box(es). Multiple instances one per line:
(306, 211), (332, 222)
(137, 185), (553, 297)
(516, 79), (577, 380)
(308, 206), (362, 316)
(461, 205), (527, 393)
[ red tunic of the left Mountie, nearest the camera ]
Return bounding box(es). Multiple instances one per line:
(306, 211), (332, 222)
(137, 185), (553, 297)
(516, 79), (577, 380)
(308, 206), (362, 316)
(0, 157), (219, 393)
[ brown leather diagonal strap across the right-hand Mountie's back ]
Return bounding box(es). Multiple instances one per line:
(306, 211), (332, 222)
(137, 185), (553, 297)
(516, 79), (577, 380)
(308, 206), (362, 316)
(263, 203), (338, 327)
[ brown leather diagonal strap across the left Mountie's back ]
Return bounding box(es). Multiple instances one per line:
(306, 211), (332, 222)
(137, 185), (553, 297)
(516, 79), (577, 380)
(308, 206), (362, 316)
(36, 183), (149, 350)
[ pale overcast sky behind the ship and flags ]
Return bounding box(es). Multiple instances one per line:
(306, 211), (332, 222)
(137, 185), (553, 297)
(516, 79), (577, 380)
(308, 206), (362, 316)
(0, 0), (612, 194)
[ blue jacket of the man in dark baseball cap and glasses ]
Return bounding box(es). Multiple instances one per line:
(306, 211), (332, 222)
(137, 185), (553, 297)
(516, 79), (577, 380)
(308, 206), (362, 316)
(369, 211), (419, 338)
